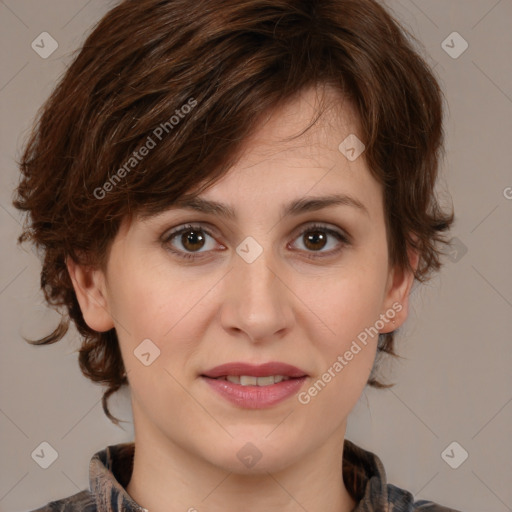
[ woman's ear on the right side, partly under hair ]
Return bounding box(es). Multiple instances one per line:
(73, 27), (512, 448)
(379, 249), (419, 334)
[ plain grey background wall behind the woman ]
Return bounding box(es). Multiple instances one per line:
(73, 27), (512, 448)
(0, 0), (512, 512)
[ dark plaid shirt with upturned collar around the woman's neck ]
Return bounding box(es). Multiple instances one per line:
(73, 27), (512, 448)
(32, 439), (460, 512)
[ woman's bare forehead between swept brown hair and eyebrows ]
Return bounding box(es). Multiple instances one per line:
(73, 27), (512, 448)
(194, 88), (382, 213)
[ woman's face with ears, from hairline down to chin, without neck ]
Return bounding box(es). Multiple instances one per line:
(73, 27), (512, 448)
(70, 86), (412, 473)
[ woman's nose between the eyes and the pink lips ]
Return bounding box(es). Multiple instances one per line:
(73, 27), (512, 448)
(220, 244), (294, 343)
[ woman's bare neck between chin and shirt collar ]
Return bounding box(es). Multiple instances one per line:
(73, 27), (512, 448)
(126, 420), (356, 512)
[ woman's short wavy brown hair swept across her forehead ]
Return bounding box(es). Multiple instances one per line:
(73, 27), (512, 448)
(14, 0), (453, 424)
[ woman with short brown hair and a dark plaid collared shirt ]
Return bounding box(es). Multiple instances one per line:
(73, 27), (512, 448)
(15, 0), (460, 512)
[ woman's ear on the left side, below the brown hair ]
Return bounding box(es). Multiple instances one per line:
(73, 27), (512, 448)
(66, 257), (114, 332)
